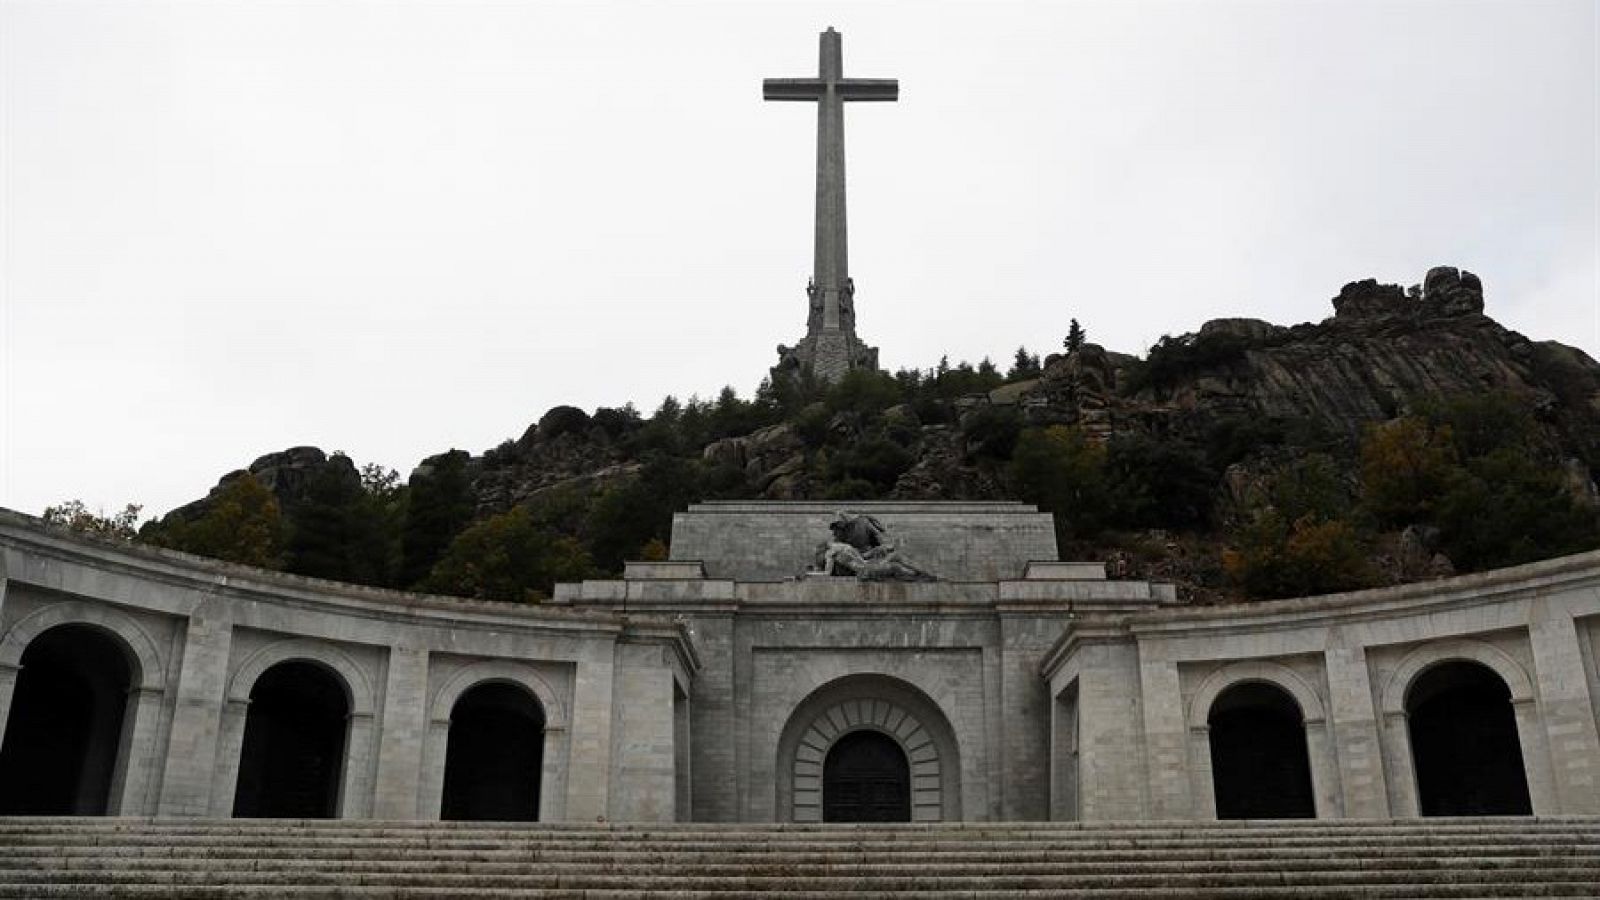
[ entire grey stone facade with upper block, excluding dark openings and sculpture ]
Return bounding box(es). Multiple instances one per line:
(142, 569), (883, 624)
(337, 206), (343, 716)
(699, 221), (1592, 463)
(0, 503), (1600, 822)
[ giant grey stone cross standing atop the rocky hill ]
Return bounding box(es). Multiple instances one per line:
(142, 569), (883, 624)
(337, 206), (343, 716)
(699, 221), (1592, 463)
(762, 29), (899, 381)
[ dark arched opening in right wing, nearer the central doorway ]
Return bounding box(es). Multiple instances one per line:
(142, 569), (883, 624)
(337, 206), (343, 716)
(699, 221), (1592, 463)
(1206, 681), (1317, 818)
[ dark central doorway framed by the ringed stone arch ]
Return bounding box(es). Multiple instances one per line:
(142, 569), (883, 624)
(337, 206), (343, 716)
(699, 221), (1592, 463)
(822, 729), (910, 822)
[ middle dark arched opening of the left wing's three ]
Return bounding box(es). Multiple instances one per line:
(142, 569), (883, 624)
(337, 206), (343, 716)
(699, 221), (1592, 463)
(234, 660), (350, 818)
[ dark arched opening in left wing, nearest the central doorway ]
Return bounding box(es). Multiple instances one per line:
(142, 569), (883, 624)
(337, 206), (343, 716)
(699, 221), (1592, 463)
(440, 682), (544, 822)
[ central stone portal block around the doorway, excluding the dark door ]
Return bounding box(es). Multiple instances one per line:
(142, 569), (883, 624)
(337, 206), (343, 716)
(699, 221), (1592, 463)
(554, 531), (1174, 822)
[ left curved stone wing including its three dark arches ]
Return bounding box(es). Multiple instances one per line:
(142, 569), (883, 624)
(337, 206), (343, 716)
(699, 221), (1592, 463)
(0, 512), (699, 822)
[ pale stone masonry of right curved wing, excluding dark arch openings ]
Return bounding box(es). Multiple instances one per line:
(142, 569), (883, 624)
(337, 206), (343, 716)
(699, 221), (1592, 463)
(1042, 552), (1600, 820)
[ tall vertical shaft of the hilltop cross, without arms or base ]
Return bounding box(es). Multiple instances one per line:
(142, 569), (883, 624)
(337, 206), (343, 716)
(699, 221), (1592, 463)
(811, 29), (853, 331)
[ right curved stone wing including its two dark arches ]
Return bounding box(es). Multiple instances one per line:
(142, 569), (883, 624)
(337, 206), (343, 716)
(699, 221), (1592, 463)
(1043, 552), (1600, 820)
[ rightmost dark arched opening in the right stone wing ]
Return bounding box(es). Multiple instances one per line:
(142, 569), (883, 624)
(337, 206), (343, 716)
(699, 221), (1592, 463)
(1405, 660), (1533, 815)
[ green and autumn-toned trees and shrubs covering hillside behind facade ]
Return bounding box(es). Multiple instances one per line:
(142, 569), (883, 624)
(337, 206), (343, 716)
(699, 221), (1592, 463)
(81, 347), (1600, 602)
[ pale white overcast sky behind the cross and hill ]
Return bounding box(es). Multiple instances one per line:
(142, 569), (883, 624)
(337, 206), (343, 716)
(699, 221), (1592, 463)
(0, 0), (1600, 514)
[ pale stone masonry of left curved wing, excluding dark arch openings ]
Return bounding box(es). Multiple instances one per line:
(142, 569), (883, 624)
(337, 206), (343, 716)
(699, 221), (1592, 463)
(0, 511), (699, 822)
